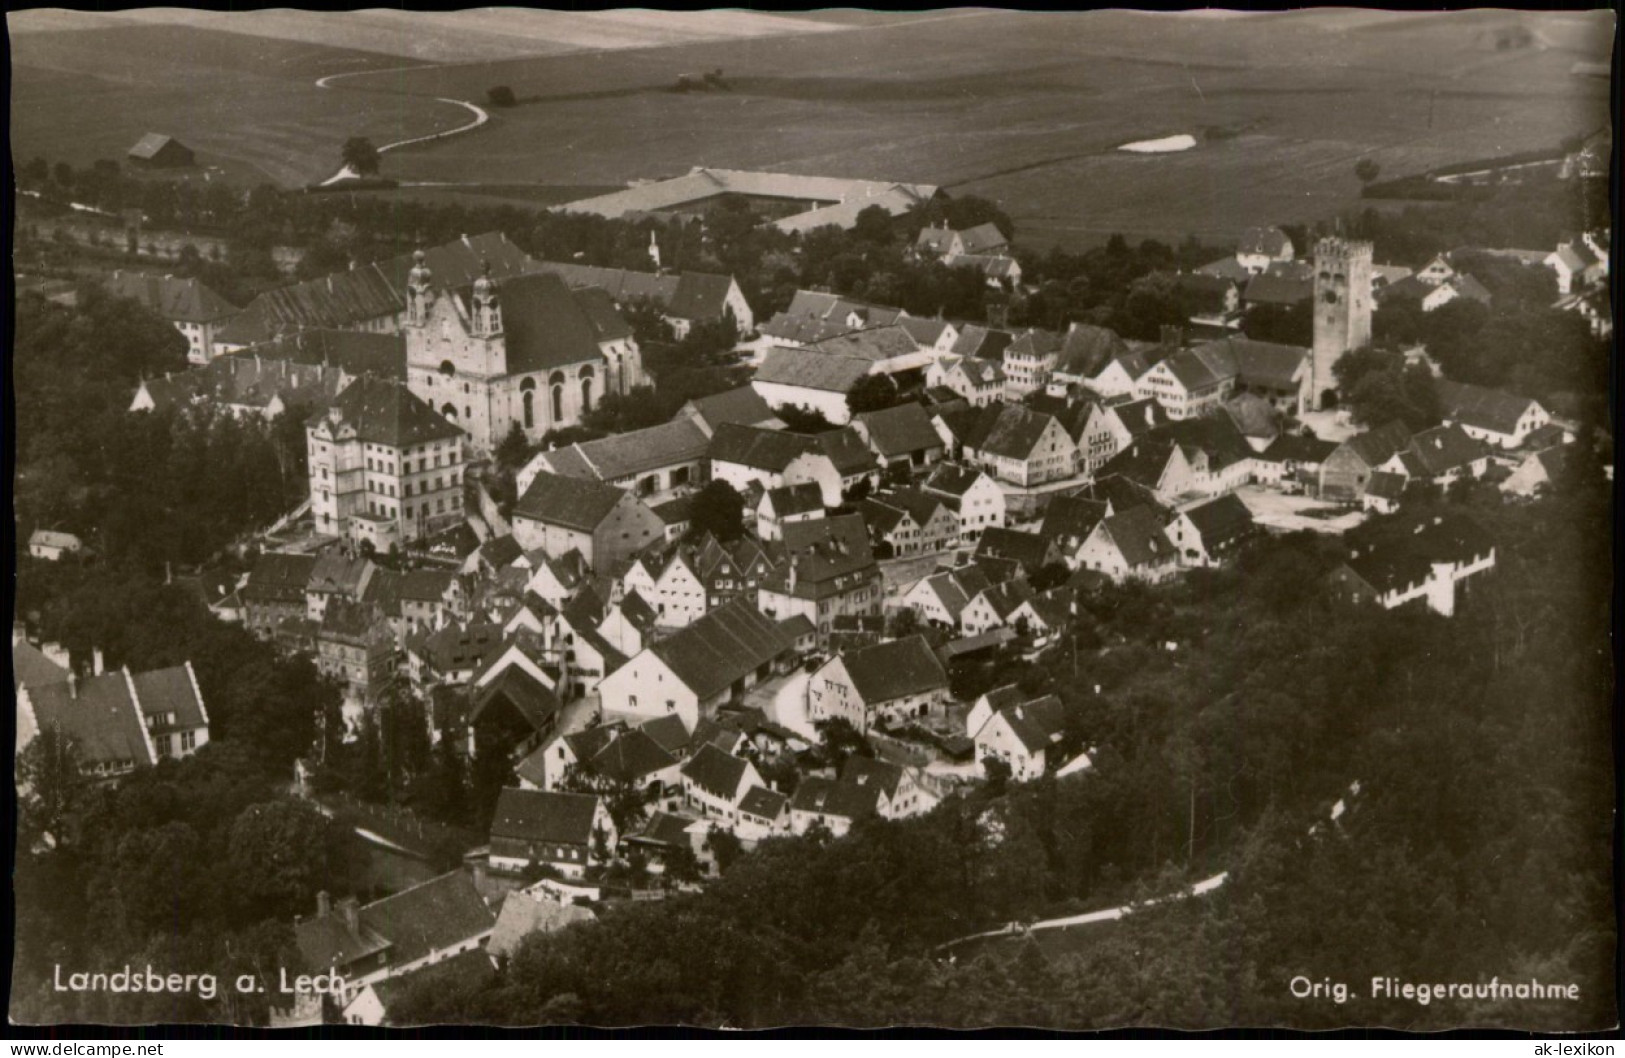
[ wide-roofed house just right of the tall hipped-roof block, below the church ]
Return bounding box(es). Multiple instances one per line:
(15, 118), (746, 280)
(514, 471), (665, 575)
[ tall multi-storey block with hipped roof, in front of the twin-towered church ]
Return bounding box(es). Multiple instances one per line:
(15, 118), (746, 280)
(306, 377), (463, 551)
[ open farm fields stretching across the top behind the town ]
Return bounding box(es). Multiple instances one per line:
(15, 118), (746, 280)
(13, 10), (1612, 247)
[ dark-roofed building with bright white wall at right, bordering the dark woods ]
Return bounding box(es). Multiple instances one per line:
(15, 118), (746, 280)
(1331, 512), (1495, 618)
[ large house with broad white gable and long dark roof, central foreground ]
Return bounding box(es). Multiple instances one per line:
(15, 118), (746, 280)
(598, 598), (793, 731)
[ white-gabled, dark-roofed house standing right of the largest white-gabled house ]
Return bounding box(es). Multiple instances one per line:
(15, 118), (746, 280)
(808, 635), (947, 731)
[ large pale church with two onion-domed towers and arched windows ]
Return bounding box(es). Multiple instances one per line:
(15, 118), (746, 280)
(405, 252), (647, 455)
